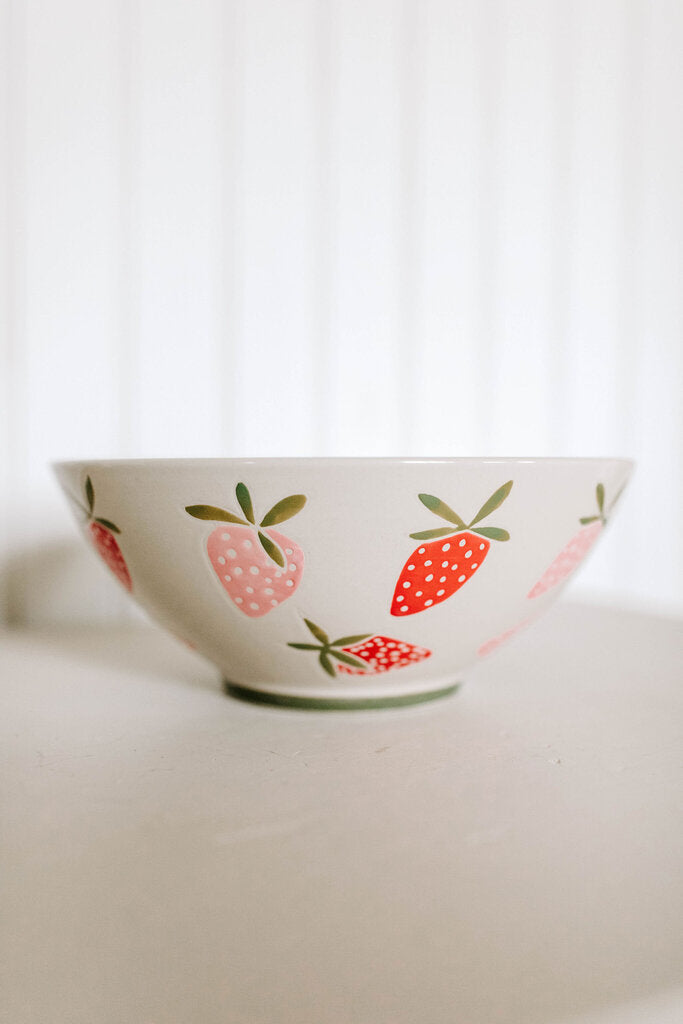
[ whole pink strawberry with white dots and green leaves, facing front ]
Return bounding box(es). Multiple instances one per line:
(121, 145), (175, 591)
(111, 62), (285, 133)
(185, 483), (306, 618)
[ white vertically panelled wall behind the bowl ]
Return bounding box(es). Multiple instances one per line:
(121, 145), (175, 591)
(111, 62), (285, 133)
(0, 0), (683, 624)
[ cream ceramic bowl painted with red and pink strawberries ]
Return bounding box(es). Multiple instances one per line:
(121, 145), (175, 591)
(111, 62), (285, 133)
(55, 459), (632, 707)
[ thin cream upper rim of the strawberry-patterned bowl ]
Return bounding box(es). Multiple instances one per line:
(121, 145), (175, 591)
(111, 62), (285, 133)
(49, 456), (636, 470)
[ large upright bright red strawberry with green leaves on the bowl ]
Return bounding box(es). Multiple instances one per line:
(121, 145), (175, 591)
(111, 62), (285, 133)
(391, 480), (512, 615)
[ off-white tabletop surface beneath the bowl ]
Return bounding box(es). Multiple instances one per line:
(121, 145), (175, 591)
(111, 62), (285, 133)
(0, 604), (683, 1024)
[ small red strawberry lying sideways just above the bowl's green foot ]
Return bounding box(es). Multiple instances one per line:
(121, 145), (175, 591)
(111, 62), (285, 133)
(288, 618), (431, 676)
